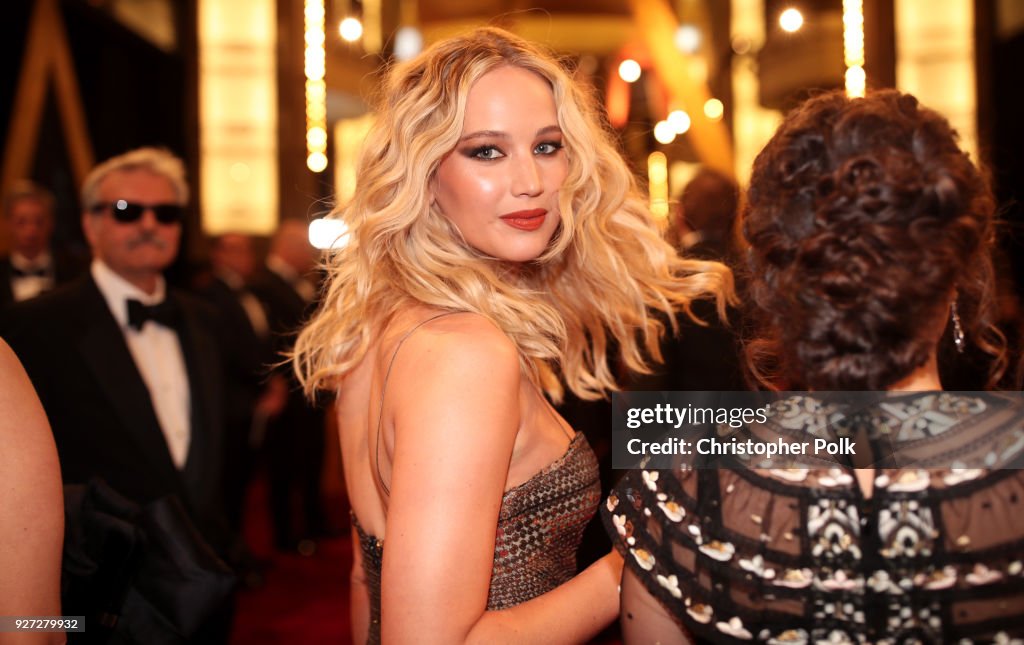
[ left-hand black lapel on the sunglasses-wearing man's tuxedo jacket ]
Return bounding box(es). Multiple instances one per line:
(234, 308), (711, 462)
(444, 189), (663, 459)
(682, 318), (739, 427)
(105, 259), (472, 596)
(78, 277), (177, 485)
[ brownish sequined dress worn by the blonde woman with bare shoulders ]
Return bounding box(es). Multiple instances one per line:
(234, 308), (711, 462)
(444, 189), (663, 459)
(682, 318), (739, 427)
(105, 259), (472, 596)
(352, 433), (601, 644)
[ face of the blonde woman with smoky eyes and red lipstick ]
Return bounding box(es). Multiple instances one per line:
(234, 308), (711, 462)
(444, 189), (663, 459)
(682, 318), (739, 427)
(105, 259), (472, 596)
(431, 67), (568, 262)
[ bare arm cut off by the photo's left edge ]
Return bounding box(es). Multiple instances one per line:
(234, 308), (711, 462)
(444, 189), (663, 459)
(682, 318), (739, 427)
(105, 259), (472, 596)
(0, 340), (65, 645)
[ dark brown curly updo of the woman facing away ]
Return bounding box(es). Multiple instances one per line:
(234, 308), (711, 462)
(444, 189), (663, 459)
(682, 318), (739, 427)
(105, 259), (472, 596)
(743, 90), (1006, 390)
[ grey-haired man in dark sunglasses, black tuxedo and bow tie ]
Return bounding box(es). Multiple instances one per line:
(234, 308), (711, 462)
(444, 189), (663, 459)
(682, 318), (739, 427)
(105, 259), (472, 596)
(4, 147), (229, 642)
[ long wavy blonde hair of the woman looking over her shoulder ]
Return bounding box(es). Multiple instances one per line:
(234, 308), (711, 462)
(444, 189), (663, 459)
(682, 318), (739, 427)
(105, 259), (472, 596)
(294, 28), (732, 401)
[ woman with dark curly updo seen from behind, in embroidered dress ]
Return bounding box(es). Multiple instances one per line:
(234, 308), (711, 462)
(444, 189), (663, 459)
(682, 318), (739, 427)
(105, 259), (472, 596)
(603, 91), (1024, 643)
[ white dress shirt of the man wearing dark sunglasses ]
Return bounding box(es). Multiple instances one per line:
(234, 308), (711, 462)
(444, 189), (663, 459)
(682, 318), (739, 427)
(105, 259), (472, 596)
(90, 259), (191, 469)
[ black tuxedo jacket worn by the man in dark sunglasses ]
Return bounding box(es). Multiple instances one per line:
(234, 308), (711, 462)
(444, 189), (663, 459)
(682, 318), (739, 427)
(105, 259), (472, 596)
(0, 274), (228, 553)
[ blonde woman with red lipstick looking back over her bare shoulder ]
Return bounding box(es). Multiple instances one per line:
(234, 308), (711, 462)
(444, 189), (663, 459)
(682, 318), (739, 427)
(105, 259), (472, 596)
(295, 29), (731, 643)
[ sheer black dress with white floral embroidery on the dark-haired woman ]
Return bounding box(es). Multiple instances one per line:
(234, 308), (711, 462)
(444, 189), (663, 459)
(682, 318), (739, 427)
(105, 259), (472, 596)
(605, 393), (1024, 645)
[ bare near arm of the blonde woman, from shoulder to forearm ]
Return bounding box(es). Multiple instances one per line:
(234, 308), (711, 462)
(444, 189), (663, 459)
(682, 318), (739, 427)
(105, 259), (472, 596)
(382, 316), (622, 644)
